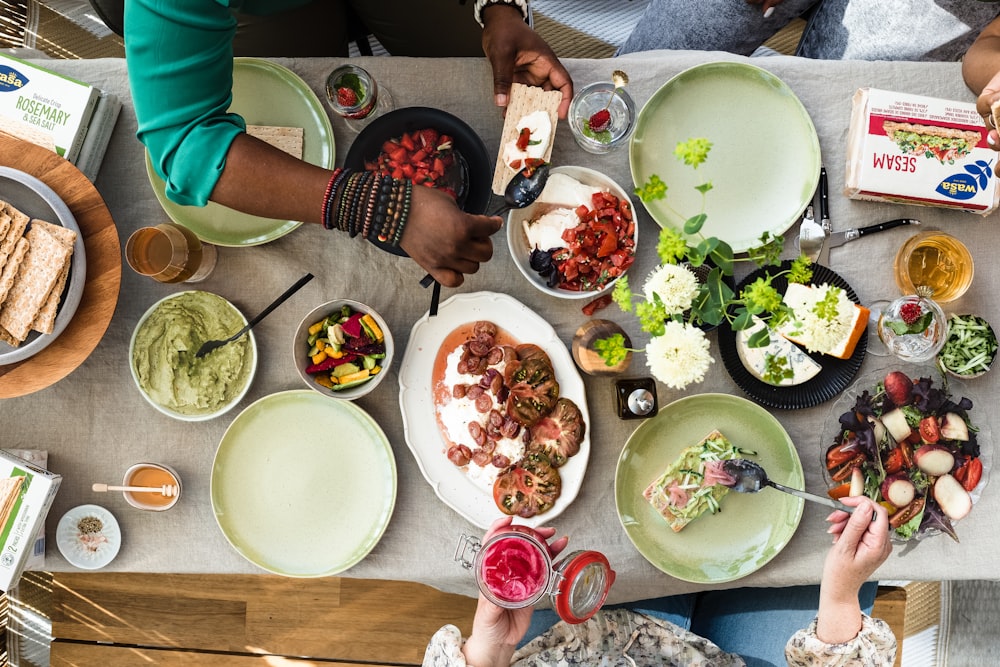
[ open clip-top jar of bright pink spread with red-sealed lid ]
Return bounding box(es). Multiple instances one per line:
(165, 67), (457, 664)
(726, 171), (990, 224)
(455, 526), (615, 623)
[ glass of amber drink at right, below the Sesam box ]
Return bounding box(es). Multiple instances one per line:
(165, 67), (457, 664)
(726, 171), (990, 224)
(893, 231), (973, 303)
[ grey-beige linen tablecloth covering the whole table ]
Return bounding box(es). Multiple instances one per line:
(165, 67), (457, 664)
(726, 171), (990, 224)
(0, 52), (1000, 602)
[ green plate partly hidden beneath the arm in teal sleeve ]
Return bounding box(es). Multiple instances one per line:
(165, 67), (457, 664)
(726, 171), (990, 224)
(146, 58), (336, 246)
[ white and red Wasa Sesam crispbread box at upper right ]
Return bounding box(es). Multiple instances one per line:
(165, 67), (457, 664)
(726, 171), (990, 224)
(844, 88), (1000, 215)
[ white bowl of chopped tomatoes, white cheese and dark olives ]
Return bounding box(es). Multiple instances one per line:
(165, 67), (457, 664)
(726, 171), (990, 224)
(507, 166), (638, 299)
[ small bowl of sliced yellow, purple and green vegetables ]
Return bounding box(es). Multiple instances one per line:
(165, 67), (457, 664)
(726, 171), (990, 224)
(292, 299), (394, 401)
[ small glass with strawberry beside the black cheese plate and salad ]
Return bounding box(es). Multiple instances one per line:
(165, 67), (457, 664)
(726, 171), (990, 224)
(869, 294), (948, 362)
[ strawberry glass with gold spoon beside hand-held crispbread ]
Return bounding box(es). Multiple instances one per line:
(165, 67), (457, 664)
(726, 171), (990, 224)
(569, 71), (636, 154)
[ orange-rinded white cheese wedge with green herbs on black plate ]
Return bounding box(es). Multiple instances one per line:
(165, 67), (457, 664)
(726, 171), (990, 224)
(778, 283), (868, 359)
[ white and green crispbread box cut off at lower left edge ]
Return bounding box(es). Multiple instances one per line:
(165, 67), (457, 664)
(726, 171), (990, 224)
(0, 450), (62, 591)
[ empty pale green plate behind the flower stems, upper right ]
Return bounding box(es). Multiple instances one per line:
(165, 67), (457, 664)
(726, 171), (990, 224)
(629, 62), (820, 253)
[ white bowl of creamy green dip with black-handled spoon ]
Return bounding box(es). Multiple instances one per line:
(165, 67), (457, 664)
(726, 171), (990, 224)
(129, 290), (257, 421)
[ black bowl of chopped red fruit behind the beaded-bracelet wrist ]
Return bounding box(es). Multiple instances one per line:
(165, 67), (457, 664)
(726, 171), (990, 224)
(344, 107), (493, 256)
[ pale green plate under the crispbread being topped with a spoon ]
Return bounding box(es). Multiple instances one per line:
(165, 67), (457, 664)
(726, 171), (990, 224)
(615, 394), (804, 583)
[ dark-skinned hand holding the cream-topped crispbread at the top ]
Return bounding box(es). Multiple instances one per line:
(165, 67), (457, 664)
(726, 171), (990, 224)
(481, 4), (573, 118)
